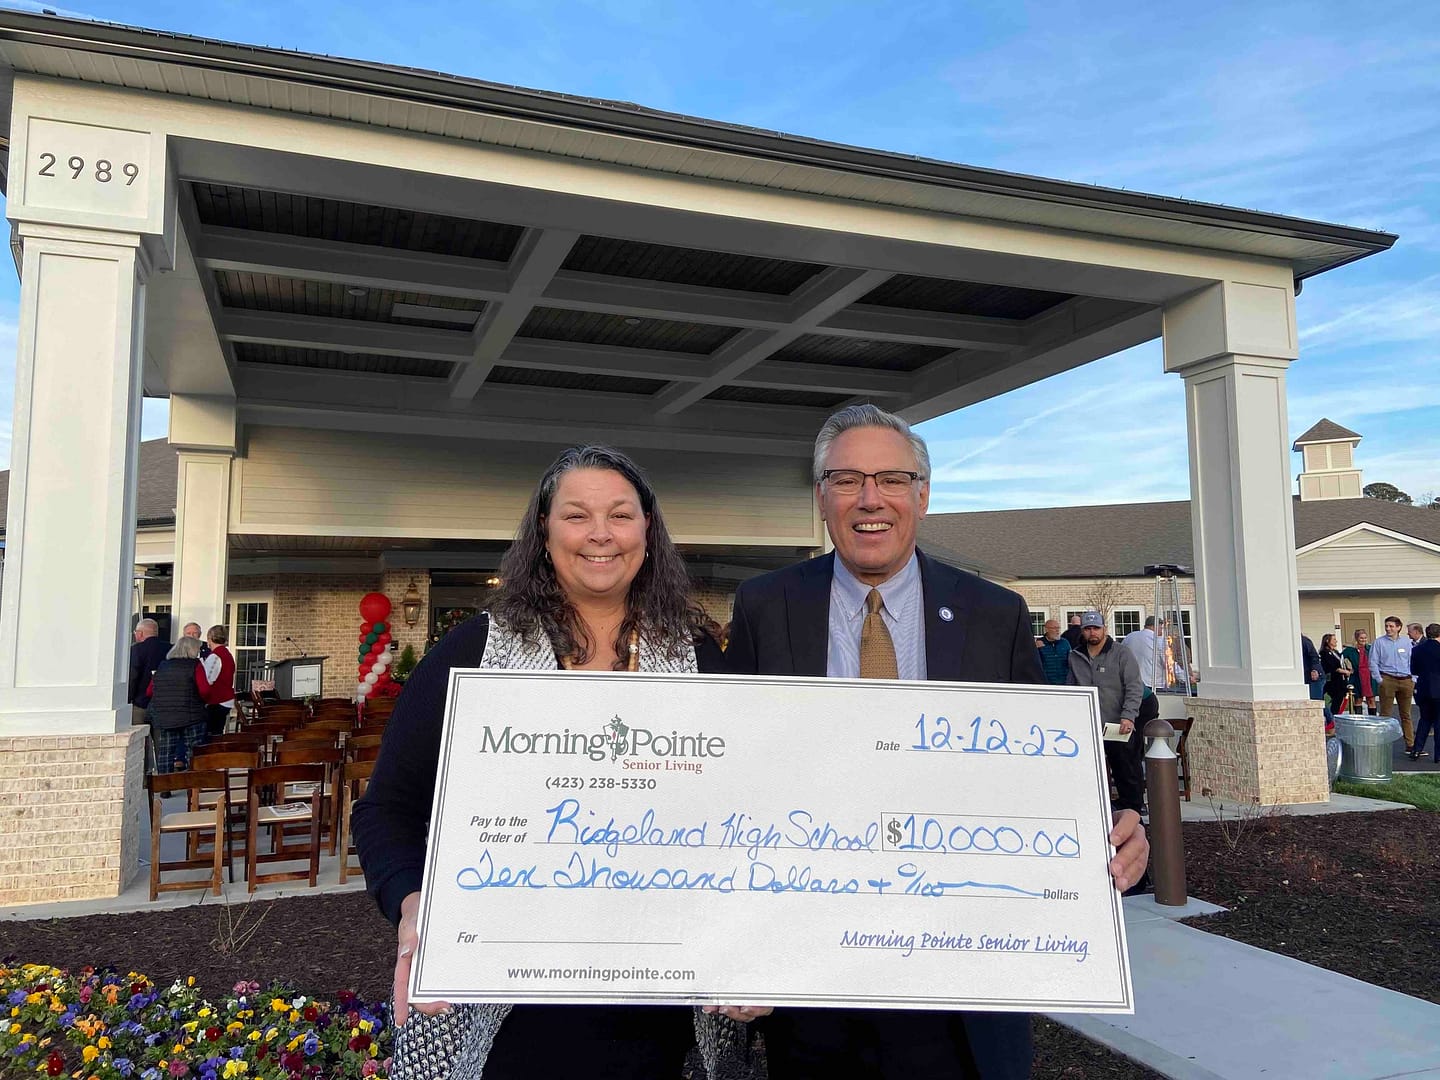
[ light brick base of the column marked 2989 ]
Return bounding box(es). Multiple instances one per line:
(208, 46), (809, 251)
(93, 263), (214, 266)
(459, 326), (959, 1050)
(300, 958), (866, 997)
(0, 729), (147, 904)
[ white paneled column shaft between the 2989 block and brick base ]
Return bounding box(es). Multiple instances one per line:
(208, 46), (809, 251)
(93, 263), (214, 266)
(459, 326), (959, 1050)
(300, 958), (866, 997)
(0, 223), (150, 734)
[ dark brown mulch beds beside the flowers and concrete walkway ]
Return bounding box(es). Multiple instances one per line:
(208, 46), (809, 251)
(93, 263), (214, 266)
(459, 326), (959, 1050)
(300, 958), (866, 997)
(0, 811), (1440, 1080)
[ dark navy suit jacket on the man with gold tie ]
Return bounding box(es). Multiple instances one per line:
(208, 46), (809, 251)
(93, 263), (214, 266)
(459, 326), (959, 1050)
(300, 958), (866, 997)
(724, 552), (1045, 1080)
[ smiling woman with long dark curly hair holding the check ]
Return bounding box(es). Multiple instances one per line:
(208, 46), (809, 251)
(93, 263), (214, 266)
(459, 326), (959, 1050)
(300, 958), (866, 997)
(354, 446), (756, 1080)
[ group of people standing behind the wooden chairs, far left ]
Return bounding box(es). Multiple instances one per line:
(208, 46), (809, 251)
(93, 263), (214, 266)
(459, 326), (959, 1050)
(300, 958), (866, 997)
(128, 618), (235, 772)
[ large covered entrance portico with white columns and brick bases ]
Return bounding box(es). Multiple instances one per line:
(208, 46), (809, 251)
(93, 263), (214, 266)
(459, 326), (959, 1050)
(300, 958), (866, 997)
(0, 12), (1394, 903)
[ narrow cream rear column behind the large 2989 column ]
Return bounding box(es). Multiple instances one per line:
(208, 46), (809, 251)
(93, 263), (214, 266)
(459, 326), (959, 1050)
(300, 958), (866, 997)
(170, 395), (235, 634)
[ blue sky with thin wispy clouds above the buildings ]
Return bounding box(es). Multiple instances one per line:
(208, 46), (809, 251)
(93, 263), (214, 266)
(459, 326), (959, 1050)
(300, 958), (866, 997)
(0, 0), (1440, 511)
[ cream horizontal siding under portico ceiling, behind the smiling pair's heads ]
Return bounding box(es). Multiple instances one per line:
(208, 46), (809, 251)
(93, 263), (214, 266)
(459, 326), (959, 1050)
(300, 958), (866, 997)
(230, 426), (821, 547)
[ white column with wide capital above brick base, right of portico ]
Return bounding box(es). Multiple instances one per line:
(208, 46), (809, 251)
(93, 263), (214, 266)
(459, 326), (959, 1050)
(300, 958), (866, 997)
(1165, 282), (1308, 701)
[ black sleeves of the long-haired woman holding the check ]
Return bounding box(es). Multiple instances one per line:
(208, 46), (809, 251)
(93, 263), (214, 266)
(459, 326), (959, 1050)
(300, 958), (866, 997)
(353, 615), (723, 924)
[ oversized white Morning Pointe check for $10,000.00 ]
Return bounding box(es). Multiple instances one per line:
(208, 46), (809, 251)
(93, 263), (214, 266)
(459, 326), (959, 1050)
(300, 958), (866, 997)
(410, 671), (1132, 1012)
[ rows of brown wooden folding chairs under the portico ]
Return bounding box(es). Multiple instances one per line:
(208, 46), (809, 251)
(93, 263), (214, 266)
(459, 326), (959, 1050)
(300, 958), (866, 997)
(147, 700), (389, 900)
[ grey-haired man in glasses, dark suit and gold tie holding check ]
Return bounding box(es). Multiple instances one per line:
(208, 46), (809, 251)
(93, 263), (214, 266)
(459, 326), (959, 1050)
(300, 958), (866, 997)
(726, 405), (1149, 1080)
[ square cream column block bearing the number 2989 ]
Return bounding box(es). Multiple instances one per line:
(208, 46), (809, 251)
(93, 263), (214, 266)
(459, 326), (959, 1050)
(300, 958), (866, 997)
(24, 117), (154, 219)
